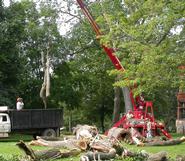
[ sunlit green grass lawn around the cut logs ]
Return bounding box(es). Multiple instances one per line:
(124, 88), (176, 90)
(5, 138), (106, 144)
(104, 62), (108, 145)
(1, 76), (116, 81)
(0, 134), (185, 161)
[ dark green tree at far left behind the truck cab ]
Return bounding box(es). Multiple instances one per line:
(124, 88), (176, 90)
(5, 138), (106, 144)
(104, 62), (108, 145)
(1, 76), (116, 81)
(0, 1), (25, 107)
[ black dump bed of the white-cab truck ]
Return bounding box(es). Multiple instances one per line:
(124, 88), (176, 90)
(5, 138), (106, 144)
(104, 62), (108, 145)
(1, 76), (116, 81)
(7, 109), (63, 137)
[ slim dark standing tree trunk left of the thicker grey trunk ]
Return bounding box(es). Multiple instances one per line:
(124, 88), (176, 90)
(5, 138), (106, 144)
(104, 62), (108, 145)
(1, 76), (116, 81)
(113, 87), (120, 124)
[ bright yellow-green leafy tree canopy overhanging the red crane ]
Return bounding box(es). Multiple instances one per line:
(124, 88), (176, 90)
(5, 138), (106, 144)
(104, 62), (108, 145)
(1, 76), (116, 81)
(97, 0), (185, 93)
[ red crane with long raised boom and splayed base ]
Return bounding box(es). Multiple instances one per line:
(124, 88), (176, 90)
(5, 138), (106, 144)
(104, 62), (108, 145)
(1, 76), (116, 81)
(77, 0), (171, 139)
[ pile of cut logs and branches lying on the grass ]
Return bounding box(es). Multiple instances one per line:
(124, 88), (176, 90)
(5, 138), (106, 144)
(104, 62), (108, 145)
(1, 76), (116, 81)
(17, 125), (185, 161)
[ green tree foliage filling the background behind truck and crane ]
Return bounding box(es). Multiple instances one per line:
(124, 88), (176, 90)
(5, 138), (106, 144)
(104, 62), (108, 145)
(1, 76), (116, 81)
(0, 0), (185, 131)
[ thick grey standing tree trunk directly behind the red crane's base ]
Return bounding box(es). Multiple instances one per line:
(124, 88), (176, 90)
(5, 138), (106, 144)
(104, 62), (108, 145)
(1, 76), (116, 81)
(122, 87), (132, 113)
